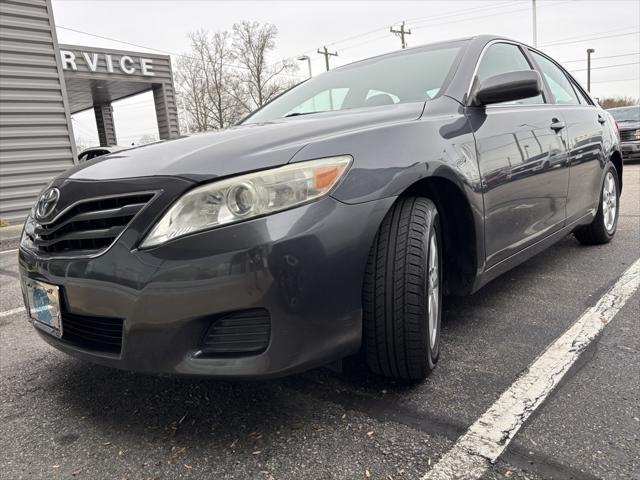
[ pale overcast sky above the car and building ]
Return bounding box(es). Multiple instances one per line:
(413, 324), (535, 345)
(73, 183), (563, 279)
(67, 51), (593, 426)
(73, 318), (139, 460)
(53, 0), (640, 145)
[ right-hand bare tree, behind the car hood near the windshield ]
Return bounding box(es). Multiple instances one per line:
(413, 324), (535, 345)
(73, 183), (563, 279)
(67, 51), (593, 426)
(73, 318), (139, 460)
(233, 21), (297, 113)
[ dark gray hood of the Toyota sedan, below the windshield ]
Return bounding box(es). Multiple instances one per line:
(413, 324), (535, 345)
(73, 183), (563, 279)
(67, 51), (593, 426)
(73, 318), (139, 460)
(66, 103), (424, 181)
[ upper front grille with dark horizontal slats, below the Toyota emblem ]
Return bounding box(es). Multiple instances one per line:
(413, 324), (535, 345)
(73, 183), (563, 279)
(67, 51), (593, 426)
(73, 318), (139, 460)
(30, 193), (153, 255)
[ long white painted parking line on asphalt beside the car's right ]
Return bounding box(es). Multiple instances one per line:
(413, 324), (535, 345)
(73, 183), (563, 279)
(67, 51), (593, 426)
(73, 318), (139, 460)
(422, 259), (640, 480)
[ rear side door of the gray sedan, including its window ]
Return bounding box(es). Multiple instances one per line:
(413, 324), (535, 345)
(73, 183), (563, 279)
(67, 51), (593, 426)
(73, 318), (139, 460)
(530, 50), (607, 224)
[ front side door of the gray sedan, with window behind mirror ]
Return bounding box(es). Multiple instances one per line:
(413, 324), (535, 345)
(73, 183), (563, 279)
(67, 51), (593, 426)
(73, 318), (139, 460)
(466, 41), (569, 267)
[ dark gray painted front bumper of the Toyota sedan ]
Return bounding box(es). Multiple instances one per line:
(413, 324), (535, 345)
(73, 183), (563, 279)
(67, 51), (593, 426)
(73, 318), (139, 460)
(19, 197), (394, 378)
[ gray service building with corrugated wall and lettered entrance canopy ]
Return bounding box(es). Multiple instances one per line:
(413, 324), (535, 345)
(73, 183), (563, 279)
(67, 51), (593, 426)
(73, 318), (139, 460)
(0, 0), (179, 222)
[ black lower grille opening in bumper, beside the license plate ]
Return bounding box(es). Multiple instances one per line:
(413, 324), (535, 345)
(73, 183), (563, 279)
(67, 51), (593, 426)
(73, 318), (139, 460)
(62, 312), (124, 354)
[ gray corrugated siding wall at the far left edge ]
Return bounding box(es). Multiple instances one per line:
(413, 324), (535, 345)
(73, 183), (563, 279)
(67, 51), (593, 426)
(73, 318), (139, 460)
(0, 0), (75, 222)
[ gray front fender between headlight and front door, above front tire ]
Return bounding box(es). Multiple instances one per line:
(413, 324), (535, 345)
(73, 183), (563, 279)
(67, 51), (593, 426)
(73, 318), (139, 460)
(292, 97), (481, 203)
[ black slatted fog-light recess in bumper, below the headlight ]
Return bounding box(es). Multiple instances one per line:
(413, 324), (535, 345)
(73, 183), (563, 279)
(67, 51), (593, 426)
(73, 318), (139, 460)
(200, 308), (271, 356)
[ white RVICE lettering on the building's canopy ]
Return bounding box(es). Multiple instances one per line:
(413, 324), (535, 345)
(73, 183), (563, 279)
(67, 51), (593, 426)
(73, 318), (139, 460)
(60, 50), (154, 77)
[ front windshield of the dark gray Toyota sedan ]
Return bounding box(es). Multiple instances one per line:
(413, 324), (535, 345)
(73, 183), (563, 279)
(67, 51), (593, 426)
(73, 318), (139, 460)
(243, 42), (463, 123)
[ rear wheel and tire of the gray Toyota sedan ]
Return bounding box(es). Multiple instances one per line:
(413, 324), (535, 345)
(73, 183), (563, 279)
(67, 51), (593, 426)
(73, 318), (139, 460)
(573, 163), (620, 245)
